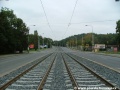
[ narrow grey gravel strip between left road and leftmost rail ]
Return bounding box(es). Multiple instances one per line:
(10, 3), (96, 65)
(0, 54), (50, 86)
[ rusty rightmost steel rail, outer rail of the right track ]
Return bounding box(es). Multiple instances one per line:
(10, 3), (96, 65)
(65, 53), (120, 90)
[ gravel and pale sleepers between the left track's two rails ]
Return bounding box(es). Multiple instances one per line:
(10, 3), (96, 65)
(6, 55), (54, 90)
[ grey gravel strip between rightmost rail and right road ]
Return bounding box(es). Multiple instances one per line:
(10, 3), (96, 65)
(69, 53), (120, 88)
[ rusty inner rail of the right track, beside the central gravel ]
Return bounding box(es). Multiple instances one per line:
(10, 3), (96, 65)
(61, 54), (79, 90)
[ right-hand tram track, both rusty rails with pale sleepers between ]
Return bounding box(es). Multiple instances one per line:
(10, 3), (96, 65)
(62, 53), (119, 90)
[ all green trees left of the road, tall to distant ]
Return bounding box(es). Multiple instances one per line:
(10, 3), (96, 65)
(0, 8), (52, 54)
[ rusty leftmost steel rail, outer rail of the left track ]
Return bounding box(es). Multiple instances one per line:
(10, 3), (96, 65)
(0, 53), (53, 90)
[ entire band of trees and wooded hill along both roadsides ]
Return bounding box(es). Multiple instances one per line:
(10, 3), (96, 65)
(0, 8), (120, 54)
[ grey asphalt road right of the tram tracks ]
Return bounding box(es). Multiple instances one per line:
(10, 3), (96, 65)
(63, 48), (120, 72)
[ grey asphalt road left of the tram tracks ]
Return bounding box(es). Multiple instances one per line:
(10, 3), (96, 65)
(0, 47), (56, 77)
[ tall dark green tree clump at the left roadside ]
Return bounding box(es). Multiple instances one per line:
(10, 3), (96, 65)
(0, 8), (29, 54)
